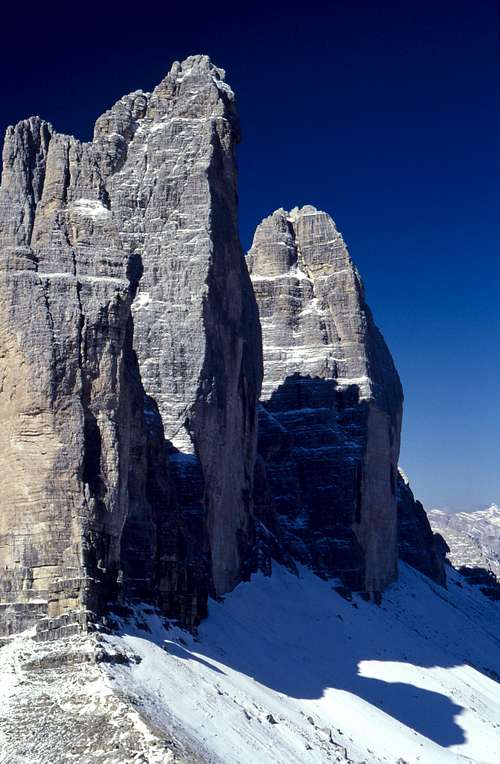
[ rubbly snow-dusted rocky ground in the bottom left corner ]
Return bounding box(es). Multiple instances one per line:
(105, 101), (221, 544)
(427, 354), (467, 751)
(0, 634), (178, 764)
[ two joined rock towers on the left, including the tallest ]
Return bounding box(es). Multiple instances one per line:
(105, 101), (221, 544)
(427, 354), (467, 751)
(0, 56), (261, 632)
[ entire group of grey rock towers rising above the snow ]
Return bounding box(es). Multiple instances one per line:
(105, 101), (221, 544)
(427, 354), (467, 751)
(0, 56), (434, 639)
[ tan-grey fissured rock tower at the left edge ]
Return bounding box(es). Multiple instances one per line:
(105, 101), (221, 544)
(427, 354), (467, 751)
(0, 118), (145, 630)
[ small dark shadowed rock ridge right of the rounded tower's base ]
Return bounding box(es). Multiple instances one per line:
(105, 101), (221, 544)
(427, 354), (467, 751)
(397, 471), (449, 586)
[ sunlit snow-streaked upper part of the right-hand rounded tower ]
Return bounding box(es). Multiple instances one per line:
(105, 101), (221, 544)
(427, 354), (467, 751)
(247, 205), (402, 410)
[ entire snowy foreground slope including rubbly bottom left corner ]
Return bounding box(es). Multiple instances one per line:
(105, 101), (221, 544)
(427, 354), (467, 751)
(0, 565), (500, 764)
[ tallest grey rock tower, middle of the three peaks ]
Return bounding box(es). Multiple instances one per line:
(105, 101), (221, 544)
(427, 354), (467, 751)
(100, 56), (262, 594)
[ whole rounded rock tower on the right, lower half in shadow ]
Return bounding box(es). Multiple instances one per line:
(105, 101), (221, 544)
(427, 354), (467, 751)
(248, 206), (402, 592)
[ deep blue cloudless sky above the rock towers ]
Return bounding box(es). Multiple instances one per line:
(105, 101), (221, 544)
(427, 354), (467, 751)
(0, 0), (500, 508)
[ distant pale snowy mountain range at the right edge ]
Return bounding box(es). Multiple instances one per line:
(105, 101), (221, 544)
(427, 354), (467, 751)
(427, 504), (500, 578)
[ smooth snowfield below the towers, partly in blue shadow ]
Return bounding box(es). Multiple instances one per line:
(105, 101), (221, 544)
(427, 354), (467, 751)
(101, 565), (500, 764)
